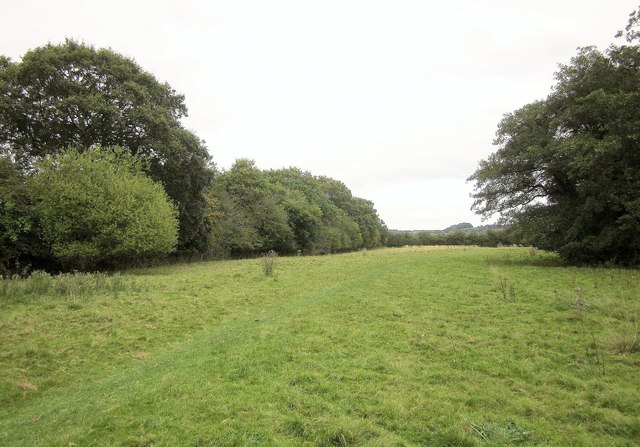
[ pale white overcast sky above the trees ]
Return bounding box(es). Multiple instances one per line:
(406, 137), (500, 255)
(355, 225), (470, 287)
(0, 0), (638, 230)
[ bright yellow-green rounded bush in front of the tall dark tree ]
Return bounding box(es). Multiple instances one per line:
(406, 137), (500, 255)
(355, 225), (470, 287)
(28, 147), (177, 269)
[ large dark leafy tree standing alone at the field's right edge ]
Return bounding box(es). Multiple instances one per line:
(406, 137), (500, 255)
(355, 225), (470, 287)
(469, 13), (640, 265)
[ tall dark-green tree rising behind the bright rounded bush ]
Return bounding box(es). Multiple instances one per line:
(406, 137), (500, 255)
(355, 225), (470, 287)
(0, 40), (211, 251)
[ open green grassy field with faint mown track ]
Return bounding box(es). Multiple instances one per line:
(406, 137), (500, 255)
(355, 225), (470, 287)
(0, 248), (640, 446)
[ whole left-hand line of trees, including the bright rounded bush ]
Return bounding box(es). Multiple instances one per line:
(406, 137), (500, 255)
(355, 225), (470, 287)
(0, 40), (387, 275)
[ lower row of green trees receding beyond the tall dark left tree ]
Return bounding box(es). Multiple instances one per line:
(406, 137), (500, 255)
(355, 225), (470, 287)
(210, 159), (386, 256)
